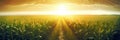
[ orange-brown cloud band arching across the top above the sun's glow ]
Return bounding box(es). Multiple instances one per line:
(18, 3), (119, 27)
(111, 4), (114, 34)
(0, 0), (120, 11)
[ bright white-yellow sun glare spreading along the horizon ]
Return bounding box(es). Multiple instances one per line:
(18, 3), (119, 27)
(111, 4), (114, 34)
(0, 3), (120, 16)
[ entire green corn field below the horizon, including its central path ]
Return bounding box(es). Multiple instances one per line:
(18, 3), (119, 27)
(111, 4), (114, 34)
(0, 15), (120, 40)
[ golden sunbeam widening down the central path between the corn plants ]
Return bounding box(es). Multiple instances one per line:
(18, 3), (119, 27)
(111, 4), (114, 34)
(49, 17), (77, 40)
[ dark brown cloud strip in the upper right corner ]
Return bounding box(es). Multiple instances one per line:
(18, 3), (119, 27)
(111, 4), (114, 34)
(70, 0), (120, 5)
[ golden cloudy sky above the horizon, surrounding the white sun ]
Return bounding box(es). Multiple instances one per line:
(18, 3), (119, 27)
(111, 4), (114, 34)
(0, 0), (120, 15)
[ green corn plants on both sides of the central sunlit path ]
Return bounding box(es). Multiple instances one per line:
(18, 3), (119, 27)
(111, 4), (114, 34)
(0, 16), (119, 40)
